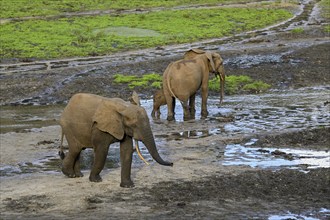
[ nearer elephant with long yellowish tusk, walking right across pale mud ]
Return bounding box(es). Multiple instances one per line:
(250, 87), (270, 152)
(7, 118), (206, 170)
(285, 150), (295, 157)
(59, 93), (173, 188)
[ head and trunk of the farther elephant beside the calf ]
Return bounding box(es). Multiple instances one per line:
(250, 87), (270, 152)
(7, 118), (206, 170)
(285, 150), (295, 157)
(184, 49), (225, 104)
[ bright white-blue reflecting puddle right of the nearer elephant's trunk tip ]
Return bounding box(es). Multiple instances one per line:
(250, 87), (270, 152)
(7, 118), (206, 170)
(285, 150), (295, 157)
(222, 139), (330, 170)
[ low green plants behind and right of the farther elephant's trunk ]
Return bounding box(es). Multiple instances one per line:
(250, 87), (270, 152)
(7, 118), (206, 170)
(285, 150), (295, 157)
(209, 75), (270, 95)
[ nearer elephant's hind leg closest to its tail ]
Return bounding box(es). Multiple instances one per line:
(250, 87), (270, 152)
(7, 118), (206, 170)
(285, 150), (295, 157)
(62, 137), (81, 178)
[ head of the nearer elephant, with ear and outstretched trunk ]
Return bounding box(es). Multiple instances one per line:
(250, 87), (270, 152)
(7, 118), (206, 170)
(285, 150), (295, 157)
(93, 93), (173, 166)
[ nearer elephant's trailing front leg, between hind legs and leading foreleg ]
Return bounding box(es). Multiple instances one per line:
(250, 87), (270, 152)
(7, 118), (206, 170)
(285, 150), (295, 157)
(89, 127), (112, 182)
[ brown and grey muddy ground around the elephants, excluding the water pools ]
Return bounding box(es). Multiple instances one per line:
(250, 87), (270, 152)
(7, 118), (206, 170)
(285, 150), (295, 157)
(0, 1), (330, 219)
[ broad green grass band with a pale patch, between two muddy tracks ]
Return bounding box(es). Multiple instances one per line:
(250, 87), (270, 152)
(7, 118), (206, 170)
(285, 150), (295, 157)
(0, 8), (292, 59)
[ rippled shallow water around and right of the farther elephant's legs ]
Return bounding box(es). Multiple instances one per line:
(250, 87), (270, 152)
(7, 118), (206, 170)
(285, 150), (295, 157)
(150, 87), (330, 134)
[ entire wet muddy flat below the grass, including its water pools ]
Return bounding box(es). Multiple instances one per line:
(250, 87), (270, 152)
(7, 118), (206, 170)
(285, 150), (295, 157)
(0, 1), (330, 219)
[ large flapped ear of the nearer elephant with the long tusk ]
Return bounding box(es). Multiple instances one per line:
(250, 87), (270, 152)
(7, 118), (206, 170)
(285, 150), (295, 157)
(93, 101), (124, 140)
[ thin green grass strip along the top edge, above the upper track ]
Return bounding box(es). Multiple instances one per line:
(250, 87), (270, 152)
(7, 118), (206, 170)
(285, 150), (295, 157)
(0, 0), (260, 18)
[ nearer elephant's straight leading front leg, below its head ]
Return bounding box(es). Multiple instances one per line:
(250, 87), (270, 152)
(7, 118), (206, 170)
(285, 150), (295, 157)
(120, 136), (134, 188)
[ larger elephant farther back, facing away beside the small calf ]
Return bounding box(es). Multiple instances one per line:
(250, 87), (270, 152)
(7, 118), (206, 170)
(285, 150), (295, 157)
(163, 49), (225, 121)
